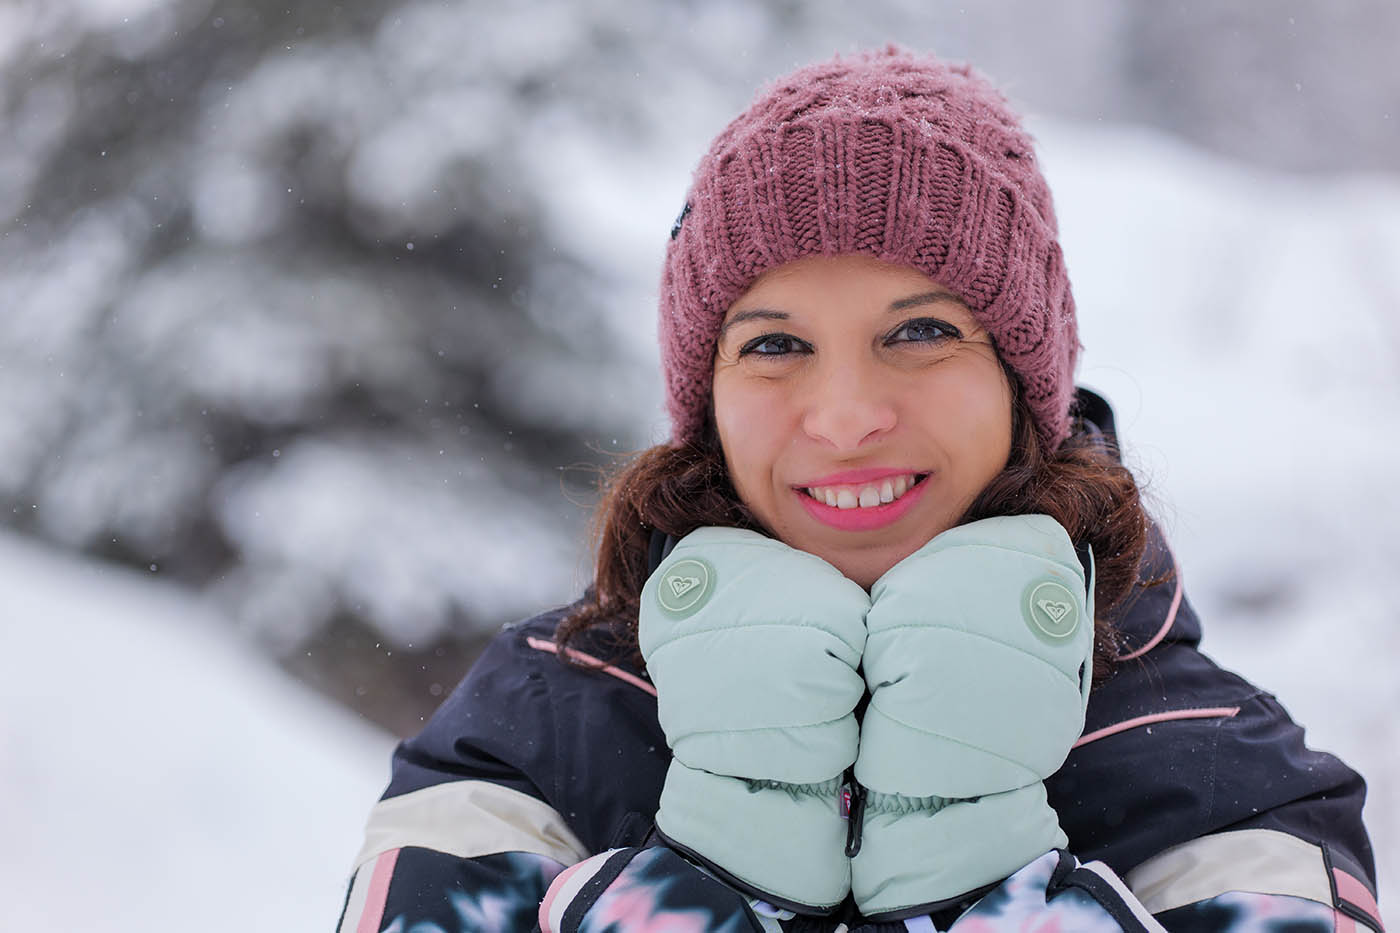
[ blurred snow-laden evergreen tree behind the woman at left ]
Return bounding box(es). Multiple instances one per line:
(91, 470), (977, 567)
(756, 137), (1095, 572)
(0, 0), (688, 728)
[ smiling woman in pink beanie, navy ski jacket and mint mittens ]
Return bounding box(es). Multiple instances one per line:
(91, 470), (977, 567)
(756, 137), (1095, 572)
(340, 49), (1380, 932)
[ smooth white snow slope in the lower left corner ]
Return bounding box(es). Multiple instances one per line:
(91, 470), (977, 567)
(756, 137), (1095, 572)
(0, 532), (392, 933)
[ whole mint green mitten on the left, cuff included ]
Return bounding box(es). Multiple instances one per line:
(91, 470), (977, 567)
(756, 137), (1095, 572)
(638, 528), (869, 912)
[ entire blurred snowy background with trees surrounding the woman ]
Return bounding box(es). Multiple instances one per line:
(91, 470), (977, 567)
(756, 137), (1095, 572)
(0, 0), (1400, 932)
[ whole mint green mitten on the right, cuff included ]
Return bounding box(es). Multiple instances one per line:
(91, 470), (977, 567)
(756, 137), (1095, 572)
(851, 516), (1093, 916)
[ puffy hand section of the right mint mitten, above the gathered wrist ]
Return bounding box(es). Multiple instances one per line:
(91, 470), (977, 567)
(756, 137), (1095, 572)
(855, 516), (1093, 797)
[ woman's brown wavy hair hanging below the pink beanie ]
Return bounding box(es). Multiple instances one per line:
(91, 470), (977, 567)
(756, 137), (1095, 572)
(554, 366), (1159, 682)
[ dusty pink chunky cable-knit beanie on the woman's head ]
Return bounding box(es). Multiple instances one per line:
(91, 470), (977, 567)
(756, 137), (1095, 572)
(659, 46), (1079, 450)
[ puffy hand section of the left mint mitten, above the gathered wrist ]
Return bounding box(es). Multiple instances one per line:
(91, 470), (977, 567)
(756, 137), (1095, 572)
(638, 528), (869, 783)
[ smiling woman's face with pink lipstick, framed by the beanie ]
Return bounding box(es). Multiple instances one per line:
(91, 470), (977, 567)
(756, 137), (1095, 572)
(714, 256), (1011, 588)
